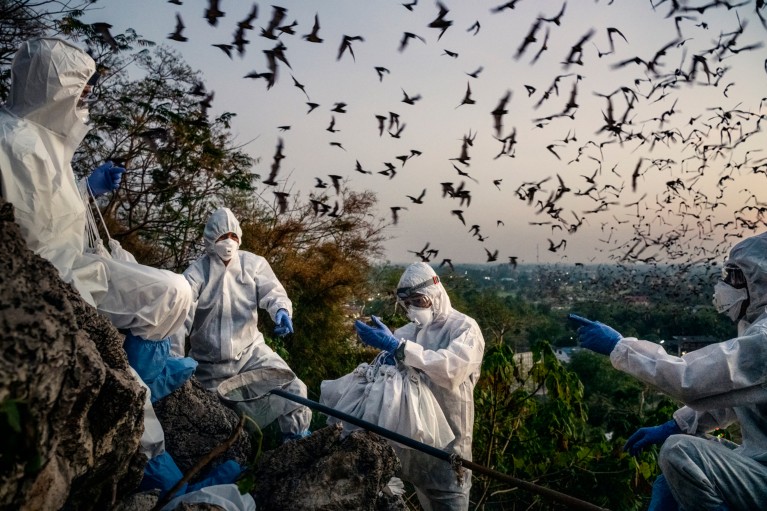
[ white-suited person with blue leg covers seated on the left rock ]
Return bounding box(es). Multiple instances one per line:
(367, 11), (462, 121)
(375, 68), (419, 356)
(0, 38), (249, 506)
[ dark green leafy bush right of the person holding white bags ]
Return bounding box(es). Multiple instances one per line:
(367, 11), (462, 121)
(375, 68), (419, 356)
(472, 342), (647, 509)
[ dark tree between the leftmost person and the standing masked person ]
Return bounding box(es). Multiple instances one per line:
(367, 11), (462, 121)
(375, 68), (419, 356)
(73, 47), (257, 271)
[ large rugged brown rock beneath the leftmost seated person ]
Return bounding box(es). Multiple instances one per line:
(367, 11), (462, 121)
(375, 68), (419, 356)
(0, 199), (146, 511)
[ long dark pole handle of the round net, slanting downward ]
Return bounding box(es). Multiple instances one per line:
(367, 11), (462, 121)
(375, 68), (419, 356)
(269, 389), (609, 511)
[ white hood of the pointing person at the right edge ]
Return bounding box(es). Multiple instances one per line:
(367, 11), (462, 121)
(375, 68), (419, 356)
(727, 232), (767, 323)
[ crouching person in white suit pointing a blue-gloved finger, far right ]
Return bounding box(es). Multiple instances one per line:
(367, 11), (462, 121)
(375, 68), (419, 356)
(571, 233), (767, 511)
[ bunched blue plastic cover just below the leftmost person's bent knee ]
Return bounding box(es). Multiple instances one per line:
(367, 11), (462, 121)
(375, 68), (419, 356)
(123, 333), (197, 403)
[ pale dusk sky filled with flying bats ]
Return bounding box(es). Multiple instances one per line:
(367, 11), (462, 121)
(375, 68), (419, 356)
(81, 0), (767, 264)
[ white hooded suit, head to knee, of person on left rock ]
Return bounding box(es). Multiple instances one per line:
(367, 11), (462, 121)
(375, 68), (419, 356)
(0, 38), (192, 339)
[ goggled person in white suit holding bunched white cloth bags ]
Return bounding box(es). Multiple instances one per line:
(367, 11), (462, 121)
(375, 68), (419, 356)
(355, 263), (485, 511)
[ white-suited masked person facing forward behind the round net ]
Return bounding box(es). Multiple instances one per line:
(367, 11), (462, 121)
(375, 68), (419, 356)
(173, 208), (312, 440)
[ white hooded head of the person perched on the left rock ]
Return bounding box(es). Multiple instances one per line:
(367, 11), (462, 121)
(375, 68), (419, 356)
(6, 37), (96, 137)
